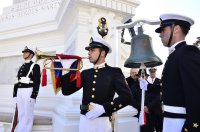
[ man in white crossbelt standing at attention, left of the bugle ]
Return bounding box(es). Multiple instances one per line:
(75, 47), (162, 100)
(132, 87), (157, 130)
(13, 46), (40, 132)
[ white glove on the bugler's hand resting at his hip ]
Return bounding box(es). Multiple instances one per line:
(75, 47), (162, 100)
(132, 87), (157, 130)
(86, 103), (105, 120)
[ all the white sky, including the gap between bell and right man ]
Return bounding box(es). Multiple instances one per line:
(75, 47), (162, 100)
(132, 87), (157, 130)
(0, 0), (200, 74)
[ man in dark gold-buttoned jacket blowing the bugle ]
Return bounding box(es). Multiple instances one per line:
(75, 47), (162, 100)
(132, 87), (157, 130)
(62, 36), (132, 132)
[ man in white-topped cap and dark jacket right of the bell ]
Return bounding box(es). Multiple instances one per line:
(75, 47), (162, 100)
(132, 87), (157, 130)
(155, 14), (200, 132)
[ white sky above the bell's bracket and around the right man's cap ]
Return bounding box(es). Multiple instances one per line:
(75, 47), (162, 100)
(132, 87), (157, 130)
(133, 0), (200, 43)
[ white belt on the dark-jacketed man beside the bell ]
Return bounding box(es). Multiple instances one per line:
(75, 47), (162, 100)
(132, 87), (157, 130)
(163, 105), (186, 114)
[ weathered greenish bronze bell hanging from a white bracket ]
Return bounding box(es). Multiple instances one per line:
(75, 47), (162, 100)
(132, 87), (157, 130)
(124, 26), (162, 68)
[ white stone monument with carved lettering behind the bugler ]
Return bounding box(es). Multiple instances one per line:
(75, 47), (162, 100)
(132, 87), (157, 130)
(0, 0), (139, 132)
